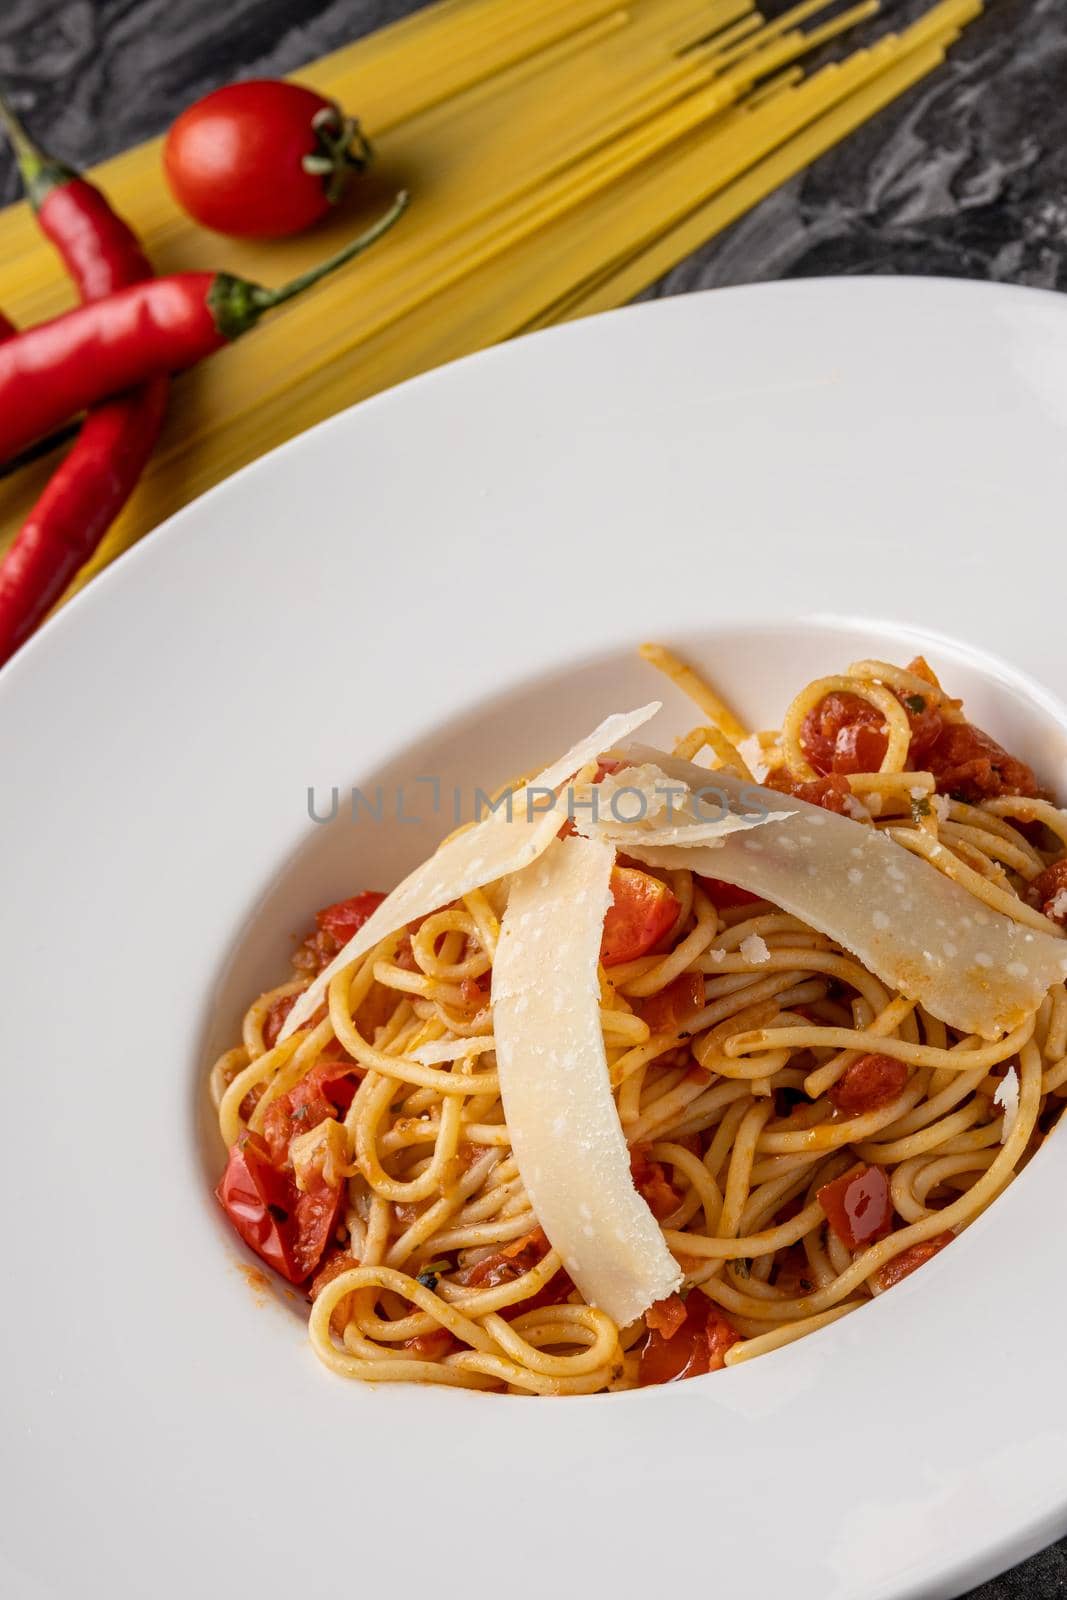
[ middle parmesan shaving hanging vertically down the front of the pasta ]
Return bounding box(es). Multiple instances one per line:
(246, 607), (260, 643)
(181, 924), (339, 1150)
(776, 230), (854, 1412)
(493, 838), (681, 1326)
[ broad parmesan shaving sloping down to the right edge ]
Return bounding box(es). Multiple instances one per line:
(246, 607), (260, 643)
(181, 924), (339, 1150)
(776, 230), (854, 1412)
(622, 749), (1067, 1038)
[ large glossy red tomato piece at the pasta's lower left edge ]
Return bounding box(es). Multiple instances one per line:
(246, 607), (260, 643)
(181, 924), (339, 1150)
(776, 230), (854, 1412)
(216, 1133), (344, 1283)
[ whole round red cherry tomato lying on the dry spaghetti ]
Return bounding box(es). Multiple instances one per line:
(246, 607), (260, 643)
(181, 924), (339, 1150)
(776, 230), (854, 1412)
(163, 78), (371, 238)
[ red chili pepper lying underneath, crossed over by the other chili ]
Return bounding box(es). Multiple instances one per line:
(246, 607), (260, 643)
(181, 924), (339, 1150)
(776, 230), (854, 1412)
(0, 101), (170, 666)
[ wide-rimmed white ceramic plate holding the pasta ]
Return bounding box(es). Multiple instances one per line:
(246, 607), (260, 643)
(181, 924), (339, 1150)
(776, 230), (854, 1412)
(0, 280), (1067, 1600)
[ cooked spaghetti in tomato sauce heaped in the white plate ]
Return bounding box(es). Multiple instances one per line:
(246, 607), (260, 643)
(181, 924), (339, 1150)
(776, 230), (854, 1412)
(211, 646), (1067, 1395)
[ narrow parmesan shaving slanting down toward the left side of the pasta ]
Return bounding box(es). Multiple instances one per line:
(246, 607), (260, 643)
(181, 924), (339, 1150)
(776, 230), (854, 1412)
(278, 701), (662, 1040)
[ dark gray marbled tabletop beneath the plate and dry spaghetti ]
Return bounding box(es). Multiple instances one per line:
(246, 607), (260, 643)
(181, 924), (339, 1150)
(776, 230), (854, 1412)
(0, 0), (1067, 1600)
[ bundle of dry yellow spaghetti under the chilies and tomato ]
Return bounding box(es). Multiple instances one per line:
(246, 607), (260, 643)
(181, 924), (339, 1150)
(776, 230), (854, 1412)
(0, 0), (981, 604)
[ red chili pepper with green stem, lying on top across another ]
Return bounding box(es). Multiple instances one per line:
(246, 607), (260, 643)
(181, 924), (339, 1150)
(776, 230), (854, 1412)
(0, 194), (408, 459)
